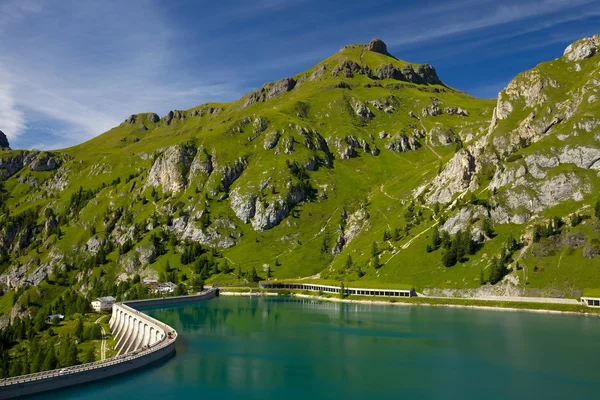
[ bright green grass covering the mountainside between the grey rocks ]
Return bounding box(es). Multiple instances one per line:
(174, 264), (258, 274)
(0, 39), (600, 313)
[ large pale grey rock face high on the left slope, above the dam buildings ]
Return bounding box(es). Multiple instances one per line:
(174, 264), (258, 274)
(146, 144), (197, 193)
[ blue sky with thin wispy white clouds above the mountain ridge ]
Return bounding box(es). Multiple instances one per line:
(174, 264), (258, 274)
(0, 0), (600, 149)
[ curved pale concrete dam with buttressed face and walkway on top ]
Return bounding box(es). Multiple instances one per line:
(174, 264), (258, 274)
(0, 289), (219, 399)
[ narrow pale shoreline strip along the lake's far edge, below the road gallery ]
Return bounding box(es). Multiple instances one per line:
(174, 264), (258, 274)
(220, 288), (600, 317)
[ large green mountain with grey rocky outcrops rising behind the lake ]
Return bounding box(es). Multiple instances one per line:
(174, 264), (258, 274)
(0, 35), (600, 318)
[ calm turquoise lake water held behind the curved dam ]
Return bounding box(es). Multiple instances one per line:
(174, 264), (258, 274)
(36, 297), (600, 400)
